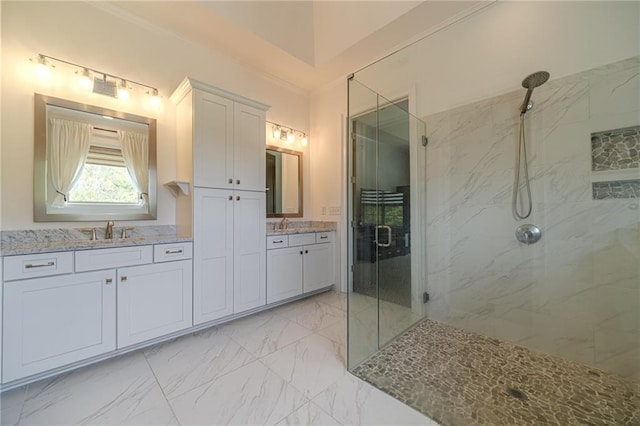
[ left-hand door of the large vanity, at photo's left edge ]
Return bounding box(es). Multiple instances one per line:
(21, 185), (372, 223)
(2, 270), (116, 382)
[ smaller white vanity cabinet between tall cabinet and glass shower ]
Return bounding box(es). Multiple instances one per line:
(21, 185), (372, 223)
(267, 232), (335, 303)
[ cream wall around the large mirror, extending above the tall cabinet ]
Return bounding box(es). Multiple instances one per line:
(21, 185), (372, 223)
(0, 2), (309, 230)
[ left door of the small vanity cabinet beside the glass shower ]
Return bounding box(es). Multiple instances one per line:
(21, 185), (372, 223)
(267, 247), (304, 303)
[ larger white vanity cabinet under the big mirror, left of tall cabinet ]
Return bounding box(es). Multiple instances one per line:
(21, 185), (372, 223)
(2, 242), (193, 383)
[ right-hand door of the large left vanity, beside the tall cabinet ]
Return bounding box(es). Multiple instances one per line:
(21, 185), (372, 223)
(117, 260), (193, 348)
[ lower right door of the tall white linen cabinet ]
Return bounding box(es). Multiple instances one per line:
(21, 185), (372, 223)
(233, 191), (267, 313)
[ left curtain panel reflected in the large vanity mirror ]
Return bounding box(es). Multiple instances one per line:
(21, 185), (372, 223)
(47, 118), (93, 208)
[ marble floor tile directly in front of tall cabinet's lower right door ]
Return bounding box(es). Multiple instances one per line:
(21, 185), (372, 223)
(220, 312), (312, 358)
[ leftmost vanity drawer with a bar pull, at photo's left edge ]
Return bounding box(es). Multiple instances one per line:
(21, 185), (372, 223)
(4, 251), (73, 281)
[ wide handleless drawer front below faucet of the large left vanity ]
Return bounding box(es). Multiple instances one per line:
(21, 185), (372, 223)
(76, 246), (153, 272)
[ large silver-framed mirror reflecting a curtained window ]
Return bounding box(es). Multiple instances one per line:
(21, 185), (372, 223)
(33, 94), (157, 222)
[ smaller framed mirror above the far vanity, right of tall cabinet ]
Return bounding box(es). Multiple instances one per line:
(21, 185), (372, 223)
(266, 145), (302, 217)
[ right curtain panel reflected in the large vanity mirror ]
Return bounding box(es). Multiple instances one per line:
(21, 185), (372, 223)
(118, 131), (149, 204)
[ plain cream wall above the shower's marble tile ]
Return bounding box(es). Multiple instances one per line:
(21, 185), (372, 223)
(356, 1), (640, 116)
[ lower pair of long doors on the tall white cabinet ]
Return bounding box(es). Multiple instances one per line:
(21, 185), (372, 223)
(193, 188), (266, 324)
